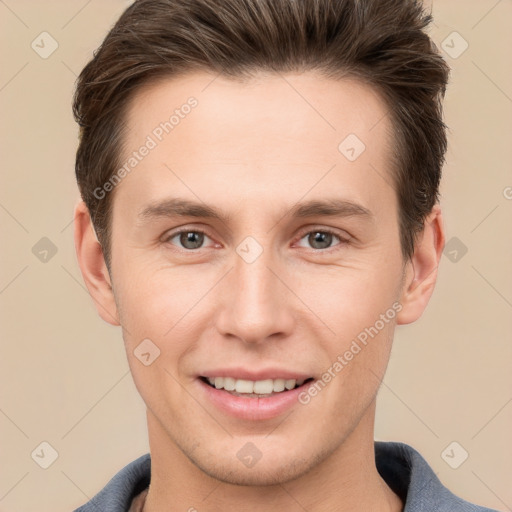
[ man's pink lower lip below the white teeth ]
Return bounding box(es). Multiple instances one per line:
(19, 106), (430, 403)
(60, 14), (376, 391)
(197, 378), (314, 421)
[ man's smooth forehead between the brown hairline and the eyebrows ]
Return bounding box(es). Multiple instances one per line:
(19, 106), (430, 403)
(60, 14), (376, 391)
(119, 72), (391, 216)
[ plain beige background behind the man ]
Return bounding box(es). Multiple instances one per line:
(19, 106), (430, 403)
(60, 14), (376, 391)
(0, 0), (512, 512)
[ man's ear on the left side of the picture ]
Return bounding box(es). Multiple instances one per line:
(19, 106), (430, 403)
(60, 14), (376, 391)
(74, 201), (120, 325)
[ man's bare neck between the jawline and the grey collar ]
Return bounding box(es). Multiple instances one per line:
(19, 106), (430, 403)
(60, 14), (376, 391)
(143, 402), (403, 512)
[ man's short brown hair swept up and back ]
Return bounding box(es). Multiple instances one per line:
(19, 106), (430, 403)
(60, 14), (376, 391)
(73, 0), (449, 270)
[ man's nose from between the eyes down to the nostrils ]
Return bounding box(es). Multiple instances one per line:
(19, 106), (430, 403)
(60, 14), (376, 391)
(219, 237), (292, 343)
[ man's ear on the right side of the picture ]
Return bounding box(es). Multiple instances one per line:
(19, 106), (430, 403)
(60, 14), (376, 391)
(397, 204), (445, 325)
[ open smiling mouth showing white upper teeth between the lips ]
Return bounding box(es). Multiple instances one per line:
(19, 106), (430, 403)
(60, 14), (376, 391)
(199, 377), (314, 398)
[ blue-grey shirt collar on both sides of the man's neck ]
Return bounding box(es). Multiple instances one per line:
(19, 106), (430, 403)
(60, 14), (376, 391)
(74, 441), (497, 512)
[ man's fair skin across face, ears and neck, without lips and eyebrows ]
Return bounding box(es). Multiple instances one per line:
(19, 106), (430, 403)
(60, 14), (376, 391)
(75, 72), (444, 512)
